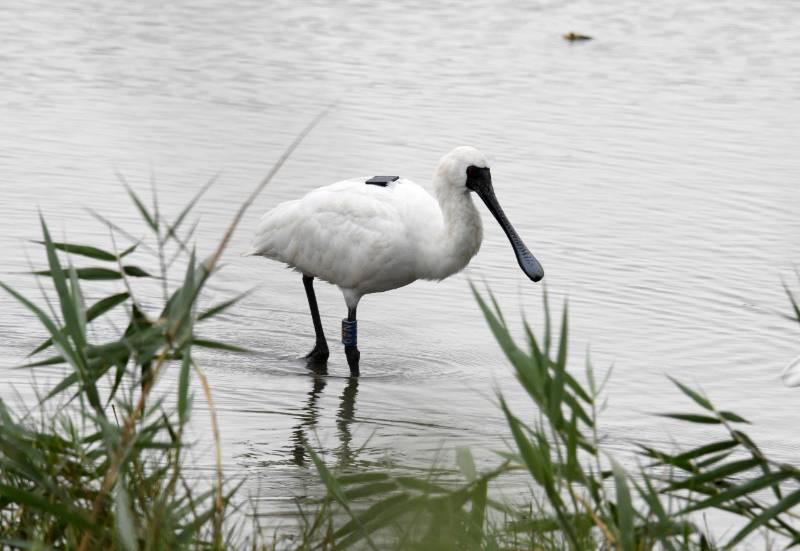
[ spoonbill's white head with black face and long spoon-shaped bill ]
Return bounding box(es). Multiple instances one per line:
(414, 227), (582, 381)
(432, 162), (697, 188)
(437, 146), (544, 281)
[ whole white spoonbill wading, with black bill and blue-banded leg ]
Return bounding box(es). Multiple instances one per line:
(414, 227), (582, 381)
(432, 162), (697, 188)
(249, 147), (544, 376)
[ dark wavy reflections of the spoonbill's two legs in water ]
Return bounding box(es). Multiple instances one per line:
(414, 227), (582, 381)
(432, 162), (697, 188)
(292, 373), (358, 466)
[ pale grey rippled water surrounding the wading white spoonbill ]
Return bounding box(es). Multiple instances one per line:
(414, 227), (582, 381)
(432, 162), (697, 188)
(0, 0), (800, 528)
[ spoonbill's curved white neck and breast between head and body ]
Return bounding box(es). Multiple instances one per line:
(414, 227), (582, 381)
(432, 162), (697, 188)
(418, 186), (483, 279)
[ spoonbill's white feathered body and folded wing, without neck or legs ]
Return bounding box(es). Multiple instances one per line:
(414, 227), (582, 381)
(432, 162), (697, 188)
(251, 178), (442, 293)
